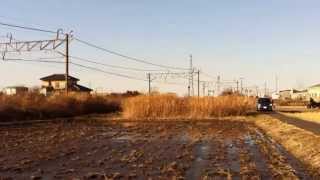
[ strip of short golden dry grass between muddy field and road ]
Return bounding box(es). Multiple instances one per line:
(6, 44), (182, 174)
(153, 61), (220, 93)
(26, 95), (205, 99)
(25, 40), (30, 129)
(254, 115), (320, 177)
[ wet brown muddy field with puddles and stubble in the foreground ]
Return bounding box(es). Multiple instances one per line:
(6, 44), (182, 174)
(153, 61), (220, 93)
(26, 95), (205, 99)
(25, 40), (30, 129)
(0, 120), (317, 179)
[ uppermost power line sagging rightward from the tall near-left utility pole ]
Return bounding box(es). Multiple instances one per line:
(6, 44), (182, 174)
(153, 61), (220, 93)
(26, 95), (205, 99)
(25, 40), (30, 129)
(74, 38), (187, 70)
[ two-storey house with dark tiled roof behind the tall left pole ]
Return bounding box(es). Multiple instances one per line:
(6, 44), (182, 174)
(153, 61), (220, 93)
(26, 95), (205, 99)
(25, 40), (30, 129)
(40, 74), (92, 95)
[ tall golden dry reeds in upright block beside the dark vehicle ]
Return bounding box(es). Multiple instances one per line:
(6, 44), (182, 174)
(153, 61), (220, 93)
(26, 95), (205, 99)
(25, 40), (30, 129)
(122, 94), (255, 119)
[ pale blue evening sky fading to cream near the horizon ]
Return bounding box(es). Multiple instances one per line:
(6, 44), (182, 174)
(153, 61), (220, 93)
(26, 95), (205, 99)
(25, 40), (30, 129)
(0, 0), (320, 94)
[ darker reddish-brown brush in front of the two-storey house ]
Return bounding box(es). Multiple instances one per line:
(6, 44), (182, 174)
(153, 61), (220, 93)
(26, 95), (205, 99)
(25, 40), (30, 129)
(0, 93), (121, 122)
